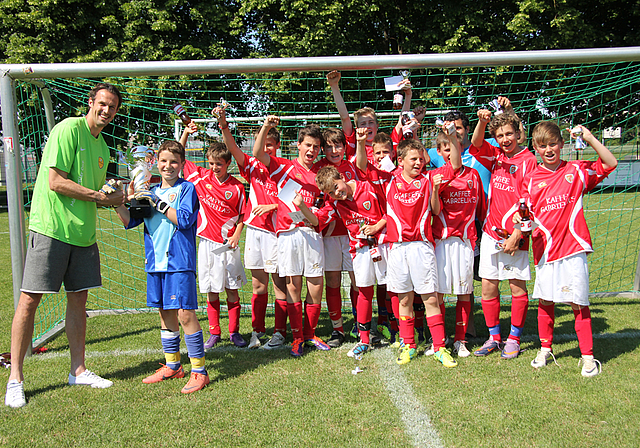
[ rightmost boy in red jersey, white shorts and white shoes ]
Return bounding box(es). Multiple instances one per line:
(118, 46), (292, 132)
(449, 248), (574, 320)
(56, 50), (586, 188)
(515, 121), (618, 377)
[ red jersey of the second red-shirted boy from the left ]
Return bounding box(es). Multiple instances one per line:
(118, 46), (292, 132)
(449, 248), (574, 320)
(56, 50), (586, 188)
(240, 154), (278, 232)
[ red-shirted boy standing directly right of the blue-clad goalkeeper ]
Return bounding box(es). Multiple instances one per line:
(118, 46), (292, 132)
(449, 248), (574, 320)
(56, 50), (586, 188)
(183, 133), (247, 350)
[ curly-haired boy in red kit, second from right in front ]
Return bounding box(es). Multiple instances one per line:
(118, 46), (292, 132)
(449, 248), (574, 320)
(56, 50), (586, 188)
(469, 109), (536, 359)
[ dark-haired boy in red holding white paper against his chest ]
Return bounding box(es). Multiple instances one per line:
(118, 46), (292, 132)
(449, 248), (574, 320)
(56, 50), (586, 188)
(253, 124), (330, 357)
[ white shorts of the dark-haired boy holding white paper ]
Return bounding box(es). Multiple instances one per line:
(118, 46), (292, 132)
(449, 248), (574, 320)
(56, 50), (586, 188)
(278, 227), (324, 277)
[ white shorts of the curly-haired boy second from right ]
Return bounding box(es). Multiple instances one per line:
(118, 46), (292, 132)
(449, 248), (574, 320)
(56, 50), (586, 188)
(478, 233), (531, 281)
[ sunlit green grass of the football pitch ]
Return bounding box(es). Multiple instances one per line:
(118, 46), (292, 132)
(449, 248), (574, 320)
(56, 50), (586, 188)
(0, 198), (640, 447)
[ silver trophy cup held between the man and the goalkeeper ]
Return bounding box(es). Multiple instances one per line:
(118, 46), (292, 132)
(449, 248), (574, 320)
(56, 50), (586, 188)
(120, 146), (156, 219)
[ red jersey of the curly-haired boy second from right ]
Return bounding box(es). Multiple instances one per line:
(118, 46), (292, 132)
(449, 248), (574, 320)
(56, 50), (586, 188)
(469, 140), (537, 245)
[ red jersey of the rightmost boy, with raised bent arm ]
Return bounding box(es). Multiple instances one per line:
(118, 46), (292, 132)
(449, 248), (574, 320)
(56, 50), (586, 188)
(525, 159), (613, 265)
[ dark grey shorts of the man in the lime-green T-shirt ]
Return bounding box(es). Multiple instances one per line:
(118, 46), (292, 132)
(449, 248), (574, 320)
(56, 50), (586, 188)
(20, 232), (102, 294)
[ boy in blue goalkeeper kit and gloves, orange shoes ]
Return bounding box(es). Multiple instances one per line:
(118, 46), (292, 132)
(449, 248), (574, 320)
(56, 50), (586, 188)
(116, 141), (209, 394)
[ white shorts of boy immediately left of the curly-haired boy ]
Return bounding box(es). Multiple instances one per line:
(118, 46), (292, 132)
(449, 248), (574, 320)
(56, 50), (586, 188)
(436, 236), (473, 295)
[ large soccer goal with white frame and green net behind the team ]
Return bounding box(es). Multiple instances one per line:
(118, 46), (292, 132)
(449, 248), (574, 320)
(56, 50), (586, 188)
(0, 47), (640, 344)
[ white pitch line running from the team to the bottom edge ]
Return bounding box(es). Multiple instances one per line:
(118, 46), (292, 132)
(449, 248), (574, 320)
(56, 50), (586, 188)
(371, 348), (444, 448)
